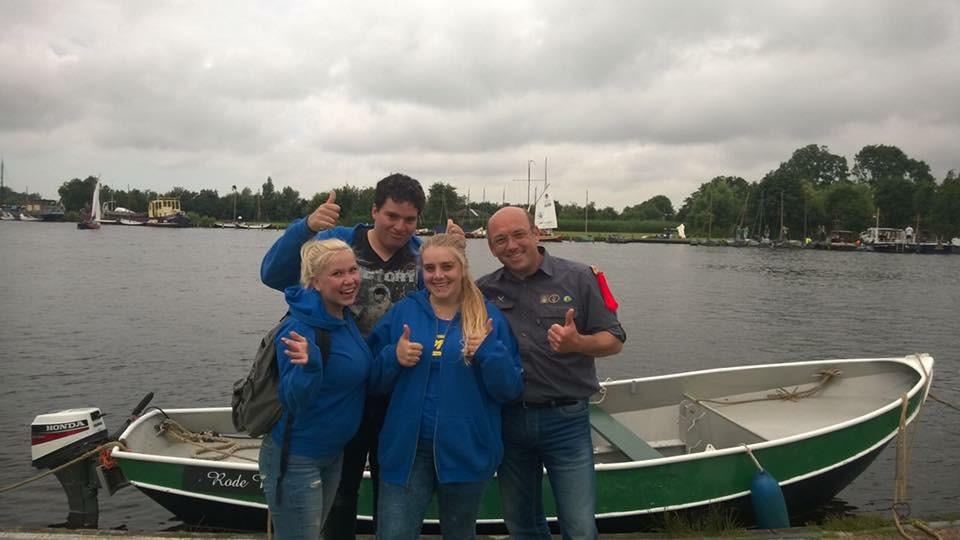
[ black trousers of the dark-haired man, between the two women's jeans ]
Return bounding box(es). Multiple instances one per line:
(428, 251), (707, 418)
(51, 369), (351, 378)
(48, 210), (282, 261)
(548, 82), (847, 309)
(323, 396), (390, 540)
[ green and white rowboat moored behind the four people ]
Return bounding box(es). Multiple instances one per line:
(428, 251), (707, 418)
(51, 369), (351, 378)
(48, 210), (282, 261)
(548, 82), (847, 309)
(112, 354), (933, 532)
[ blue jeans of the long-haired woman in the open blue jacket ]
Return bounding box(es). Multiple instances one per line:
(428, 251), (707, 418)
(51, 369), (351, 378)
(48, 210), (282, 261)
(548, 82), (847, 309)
(377, 439), (488, 540)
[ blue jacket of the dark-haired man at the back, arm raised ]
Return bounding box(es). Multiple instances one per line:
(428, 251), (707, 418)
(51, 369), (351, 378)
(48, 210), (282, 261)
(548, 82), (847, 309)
(260, 218), (423, 291)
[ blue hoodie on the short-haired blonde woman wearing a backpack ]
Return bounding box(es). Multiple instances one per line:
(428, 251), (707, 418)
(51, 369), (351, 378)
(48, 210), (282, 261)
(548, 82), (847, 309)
(271, 285), (373, 458)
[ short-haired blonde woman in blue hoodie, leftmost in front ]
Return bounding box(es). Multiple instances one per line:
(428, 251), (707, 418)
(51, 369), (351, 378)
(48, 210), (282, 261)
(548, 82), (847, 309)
(260, 239), (373, 540)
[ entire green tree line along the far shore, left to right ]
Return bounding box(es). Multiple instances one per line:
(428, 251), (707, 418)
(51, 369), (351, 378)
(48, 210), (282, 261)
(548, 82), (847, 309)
(2, 144), (960, 239)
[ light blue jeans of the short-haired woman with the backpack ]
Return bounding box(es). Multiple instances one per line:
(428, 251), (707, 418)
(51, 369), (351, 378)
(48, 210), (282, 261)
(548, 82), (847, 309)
(260, 433), (343, 540)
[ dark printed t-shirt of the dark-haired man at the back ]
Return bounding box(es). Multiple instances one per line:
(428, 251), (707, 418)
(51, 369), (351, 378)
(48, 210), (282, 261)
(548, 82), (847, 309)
(350, 229), (417, 337)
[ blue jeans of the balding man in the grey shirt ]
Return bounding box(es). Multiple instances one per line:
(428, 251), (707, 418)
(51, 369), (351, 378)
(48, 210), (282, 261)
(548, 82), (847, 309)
(498, 399), (597, 540)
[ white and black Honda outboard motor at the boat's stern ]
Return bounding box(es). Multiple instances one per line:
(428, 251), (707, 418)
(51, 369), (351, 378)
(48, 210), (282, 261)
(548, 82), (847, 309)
(30, 392), (153, 529)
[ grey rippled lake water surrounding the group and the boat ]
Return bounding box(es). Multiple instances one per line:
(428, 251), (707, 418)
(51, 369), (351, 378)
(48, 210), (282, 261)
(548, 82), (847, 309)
(0, 222), (960, 531)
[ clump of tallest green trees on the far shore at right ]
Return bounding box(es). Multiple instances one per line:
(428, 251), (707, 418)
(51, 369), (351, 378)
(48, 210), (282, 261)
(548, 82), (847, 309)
(676, 144), (960, 239)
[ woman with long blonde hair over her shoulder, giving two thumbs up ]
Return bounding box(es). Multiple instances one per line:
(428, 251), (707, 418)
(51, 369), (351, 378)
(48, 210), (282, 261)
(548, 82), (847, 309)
(369, 234), (523, 540)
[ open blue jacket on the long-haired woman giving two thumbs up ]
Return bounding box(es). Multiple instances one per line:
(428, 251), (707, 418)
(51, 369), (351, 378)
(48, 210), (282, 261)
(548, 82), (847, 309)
(368, 290), (523, 485)
